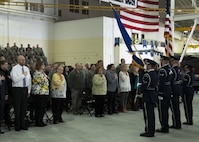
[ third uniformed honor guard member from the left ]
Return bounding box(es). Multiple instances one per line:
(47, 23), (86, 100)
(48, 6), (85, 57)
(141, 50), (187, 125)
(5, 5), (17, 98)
(169, 56), (182, 129)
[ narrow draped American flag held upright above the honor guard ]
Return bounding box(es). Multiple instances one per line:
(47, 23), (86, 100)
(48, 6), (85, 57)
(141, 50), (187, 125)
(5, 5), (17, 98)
(164, 0), (173, 57)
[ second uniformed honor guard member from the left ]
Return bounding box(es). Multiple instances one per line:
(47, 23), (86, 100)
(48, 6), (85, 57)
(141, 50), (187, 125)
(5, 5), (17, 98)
(156, 55), (173, 133)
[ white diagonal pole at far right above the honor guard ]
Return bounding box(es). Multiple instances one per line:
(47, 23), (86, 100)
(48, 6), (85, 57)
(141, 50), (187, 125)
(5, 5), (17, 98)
(179, 19), (198, 63)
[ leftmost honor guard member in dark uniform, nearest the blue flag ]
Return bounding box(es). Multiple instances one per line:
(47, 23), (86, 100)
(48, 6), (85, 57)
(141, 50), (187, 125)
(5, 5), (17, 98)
(140, 59), (158, 137)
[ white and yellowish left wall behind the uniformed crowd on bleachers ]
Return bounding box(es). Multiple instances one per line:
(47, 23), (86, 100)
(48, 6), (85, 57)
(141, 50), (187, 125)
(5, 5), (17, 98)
(0, 14), (54, 60)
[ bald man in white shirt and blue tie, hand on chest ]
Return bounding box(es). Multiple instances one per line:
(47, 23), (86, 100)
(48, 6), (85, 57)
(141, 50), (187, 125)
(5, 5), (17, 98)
(10, 55), (31, 131)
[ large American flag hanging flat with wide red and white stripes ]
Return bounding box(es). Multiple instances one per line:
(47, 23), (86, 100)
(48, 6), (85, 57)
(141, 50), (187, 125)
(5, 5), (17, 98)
(120, 0), (159, 32)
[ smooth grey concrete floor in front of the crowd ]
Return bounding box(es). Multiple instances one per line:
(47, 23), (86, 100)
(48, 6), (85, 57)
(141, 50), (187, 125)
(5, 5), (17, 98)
(0, 94), (199, 142)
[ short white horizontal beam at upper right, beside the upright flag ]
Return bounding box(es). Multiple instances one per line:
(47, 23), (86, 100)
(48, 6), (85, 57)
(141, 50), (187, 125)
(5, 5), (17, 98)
(173, 14), (199, 22)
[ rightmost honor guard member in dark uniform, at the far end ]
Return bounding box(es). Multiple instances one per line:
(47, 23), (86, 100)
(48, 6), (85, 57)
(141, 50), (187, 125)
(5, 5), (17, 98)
(183, 64), (195, 125)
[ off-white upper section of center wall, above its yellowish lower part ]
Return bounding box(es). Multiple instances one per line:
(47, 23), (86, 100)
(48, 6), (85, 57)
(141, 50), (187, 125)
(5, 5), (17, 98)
(55, 17), (103, 40)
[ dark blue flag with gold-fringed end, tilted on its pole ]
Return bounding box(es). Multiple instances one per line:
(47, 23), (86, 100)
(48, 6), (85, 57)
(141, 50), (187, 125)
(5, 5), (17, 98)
(113, 8), (144, 68)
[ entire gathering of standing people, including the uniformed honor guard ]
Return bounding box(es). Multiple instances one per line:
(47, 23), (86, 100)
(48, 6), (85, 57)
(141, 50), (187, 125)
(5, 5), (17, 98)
(0, 45), (197, 137)
